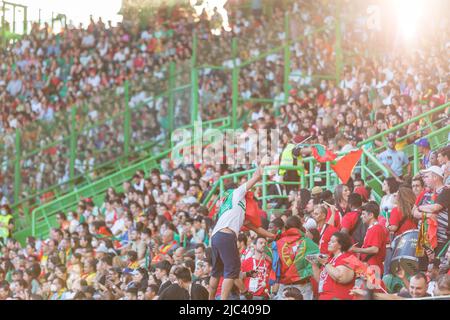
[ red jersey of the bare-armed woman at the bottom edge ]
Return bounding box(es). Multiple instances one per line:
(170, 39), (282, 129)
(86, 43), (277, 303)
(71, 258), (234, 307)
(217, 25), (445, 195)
(319, 252), (355, 300)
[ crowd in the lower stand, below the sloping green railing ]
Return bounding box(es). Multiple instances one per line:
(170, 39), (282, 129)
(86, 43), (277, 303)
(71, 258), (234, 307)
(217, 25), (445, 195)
(0, 147), (450, 300)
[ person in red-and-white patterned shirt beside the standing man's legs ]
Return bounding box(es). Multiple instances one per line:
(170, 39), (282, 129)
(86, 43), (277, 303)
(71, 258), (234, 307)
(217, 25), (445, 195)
(241, 237), (272, 300)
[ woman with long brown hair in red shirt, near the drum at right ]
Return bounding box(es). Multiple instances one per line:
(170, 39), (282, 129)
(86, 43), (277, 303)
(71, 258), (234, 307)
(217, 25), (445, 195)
(388, 187), (417, 237)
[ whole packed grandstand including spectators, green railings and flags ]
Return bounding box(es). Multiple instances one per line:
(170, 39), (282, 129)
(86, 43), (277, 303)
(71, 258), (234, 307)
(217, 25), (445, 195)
(0, 0), (450, 300)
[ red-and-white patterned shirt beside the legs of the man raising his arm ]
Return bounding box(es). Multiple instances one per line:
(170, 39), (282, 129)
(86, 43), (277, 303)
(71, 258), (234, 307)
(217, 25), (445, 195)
(241, 257), (271, 297)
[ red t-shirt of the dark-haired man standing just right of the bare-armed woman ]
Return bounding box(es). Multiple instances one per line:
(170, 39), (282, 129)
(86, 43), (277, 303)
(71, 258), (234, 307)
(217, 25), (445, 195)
(361, 223), (387, 272)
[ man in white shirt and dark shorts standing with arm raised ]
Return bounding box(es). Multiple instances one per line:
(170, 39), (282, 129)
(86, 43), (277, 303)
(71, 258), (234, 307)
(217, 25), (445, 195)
(209, 156), (275, 300)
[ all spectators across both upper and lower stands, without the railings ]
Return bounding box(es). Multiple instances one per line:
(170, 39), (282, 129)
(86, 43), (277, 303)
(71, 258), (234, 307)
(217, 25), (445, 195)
(0, 0), (450, 300)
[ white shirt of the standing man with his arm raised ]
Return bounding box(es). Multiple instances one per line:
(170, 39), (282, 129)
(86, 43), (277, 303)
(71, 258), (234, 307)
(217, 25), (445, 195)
(212, 183), (247, 236)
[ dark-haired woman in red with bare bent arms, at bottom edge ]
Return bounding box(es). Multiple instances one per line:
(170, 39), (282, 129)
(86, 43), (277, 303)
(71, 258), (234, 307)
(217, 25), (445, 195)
(307, 232), (356, 300)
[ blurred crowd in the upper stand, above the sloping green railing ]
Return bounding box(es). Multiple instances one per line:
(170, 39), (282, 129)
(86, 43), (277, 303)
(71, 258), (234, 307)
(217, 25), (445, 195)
(0, 3), (448, 206)
